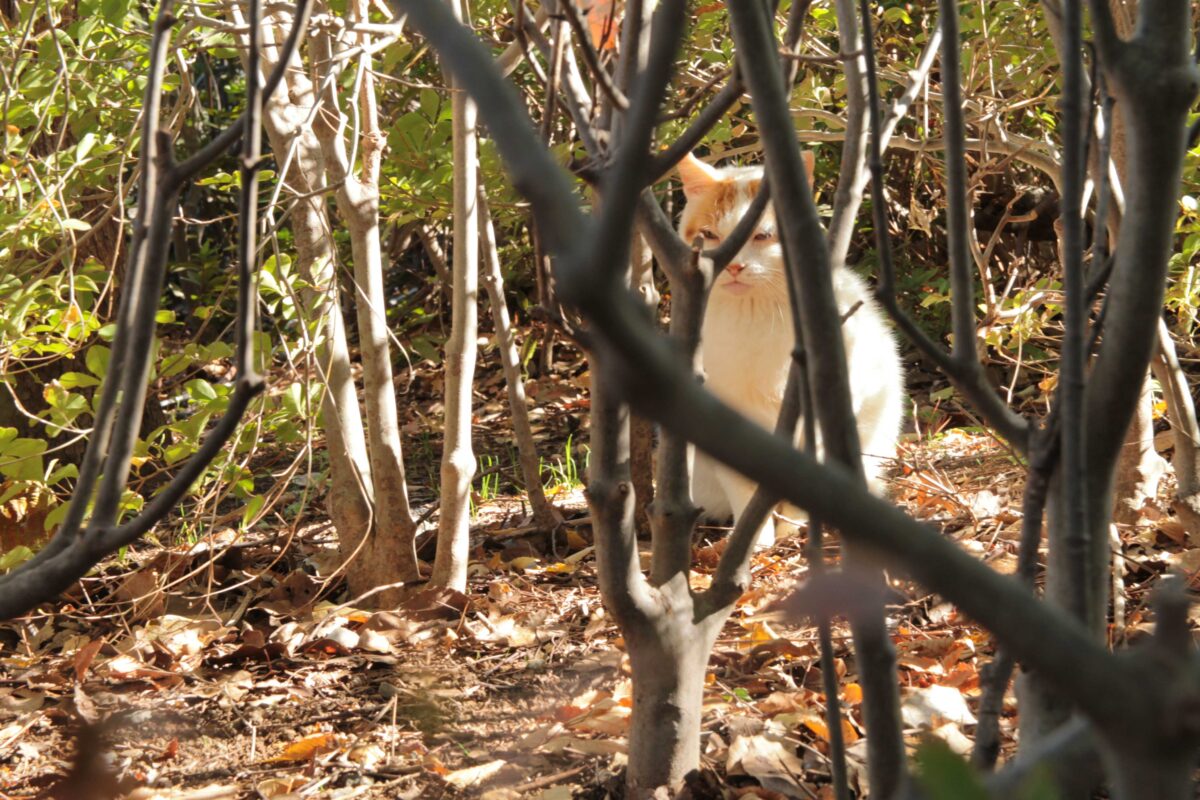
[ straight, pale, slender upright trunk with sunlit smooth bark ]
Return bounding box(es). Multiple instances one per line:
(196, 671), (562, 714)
(431, 0), (479, 591)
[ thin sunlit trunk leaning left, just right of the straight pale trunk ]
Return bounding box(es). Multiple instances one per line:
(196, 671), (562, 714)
(479, 186), (563, 531)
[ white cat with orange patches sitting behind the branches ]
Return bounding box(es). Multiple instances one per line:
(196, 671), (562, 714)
(678, 151), (905, 547)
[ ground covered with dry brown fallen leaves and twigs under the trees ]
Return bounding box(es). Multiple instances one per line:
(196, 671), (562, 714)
(0, 357), (1185, 800)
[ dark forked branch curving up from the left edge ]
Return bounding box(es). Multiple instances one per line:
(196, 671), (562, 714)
(0, 0), (310, 619)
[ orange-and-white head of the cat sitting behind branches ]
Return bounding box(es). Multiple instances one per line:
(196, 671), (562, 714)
(679, 152), (812, 302)
